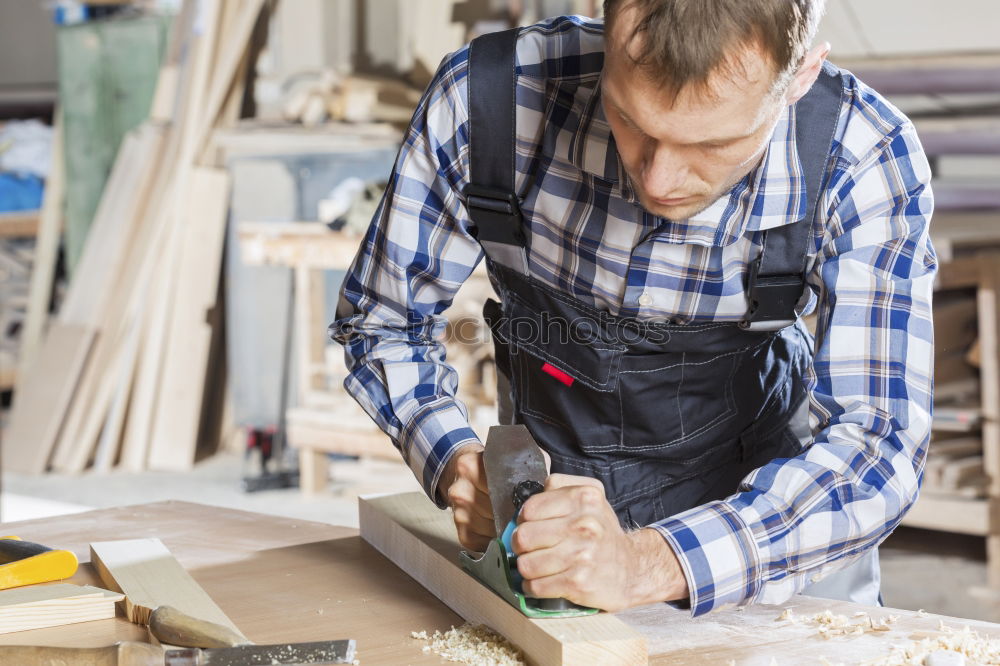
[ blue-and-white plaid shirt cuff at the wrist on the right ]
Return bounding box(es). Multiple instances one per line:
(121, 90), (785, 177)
(649, 502), (762, 617)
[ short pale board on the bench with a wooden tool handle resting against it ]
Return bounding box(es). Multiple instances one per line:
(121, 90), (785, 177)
(90, 539), (249, 642)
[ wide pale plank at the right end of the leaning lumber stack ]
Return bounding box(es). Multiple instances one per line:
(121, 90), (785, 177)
(147, 167), (230, 470)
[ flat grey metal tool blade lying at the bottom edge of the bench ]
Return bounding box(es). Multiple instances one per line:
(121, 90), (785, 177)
(164, 640), (356, 666)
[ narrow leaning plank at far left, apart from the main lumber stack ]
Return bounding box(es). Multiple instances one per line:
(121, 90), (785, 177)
(20, 116), (66, 368)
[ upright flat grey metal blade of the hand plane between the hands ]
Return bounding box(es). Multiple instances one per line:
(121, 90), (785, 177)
(483, 425), (549, 537)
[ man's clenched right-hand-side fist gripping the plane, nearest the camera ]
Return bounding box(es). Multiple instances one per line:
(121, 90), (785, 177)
(511, 474), (688, 611)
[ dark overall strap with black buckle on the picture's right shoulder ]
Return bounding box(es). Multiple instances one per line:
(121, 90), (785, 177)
(742, 63), (844, 331)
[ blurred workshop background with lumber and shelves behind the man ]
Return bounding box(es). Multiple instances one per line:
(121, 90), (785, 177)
(0, 0), (1000, 621)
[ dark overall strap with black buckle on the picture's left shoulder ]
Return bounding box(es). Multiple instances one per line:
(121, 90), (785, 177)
(465, 28), (528, 274)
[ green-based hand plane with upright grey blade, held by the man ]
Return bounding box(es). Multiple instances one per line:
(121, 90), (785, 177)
(459, 425), (598, 618)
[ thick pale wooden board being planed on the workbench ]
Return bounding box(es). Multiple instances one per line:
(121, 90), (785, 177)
(358, 493), (648, 664)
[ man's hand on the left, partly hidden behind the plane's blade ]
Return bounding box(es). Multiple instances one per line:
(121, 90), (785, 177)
(438, 444), (496, 553)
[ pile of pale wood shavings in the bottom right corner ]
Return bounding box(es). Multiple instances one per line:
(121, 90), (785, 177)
(865, 625), (1000, 666)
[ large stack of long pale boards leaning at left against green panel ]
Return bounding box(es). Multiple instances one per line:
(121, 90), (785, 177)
(2, 0), (265, 473)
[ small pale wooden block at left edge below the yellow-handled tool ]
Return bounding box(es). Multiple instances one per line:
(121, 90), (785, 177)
(0, 583), (124, 634)
